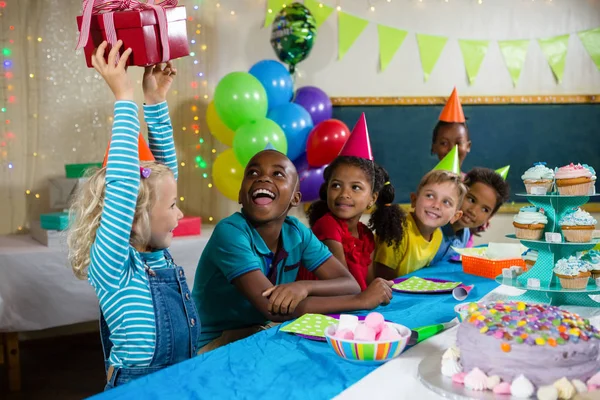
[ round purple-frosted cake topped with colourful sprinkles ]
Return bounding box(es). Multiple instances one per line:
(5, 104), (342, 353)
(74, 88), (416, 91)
(457, 301), (600, 387)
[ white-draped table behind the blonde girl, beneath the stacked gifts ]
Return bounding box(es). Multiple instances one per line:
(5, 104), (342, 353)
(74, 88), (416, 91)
(0, 231), (212, 390)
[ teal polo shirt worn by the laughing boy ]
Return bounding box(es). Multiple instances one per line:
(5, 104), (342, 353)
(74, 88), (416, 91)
(192, 212), (331, 347)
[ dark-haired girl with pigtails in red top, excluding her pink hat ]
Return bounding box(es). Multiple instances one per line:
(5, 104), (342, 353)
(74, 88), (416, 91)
(296, 156), (406, 290)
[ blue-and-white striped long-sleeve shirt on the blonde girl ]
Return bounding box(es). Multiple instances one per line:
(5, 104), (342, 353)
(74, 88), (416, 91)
(88, 101), (177, 367)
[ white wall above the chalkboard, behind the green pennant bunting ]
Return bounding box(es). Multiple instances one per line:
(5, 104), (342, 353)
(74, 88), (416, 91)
(204, 0), (600, 96)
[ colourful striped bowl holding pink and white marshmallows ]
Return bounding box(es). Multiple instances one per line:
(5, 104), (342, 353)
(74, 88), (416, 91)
(325, 322), (410, 364)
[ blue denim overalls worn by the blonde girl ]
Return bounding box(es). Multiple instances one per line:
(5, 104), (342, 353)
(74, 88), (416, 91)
(100, 250), (200, 390)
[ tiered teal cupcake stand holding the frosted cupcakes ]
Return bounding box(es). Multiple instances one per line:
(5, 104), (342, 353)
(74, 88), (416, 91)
(496, 193), (600, 307)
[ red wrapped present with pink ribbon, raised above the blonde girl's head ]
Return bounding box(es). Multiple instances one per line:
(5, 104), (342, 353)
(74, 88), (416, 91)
(77, 0), (190, 68)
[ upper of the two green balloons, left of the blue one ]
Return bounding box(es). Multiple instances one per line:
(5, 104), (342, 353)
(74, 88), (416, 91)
(214, 72), (267, 130)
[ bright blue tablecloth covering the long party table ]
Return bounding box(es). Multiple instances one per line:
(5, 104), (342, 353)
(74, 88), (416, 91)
(94, 263), (498, 400)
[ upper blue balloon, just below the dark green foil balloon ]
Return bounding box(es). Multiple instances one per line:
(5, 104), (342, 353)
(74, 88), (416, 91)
(249, 60), (294, 110)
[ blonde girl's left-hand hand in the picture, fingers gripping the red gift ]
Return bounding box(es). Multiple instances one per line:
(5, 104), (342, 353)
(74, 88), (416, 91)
(92, 40), (133, 100)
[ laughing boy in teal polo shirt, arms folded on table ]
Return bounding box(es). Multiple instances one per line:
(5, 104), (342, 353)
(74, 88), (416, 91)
(192, 150), (392, 353)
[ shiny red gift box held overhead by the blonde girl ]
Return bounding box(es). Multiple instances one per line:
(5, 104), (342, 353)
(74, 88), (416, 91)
(77, 3), (190, 68)
